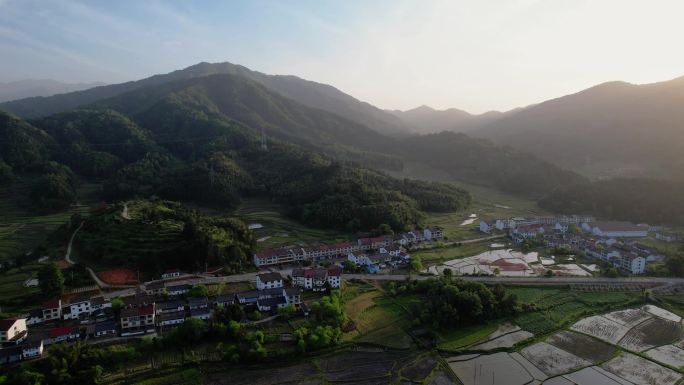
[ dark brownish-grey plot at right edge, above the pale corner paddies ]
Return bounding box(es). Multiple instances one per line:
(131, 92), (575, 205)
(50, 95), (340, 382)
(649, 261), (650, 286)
(619, 317), (682, 352)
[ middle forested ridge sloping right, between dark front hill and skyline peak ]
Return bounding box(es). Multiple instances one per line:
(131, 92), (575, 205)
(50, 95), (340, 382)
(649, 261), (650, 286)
(92, 75), (582, 198)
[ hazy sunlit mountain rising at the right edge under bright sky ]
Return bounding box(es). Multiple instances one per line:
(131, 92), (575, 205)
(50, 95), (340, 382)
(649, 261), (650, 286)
(469, 77), (684, 180)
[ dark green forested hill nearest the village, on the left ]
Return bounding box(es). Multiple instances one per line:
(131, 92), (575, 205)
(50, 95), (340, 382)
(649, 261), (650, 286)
(0, 95), (470, 231)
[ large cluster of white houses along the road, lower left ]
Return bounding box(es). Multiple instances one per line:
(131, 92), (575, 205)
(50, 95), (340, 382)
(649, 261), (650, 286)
(0, 267), (341, 364)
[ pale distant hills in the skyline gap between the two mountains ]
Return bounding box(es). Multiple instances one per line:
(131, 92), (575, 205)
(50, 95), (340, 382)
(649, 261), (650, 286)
(388, 105), (515, 134)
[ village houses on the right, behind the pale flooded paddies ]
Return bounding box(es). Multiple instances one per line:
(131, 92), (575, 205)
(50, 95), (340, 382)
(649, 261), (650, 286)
(480, 216), (664, 274)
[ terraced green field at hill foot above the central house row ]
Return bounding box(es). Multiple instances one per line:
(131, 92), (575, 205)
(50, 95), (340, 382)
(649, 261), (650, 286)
(235, 199), (350, 249)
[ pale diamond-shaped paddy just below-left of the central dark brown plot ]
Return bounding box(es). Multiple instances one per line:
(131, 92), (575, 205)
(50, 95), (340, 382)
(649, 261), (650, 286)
(520, 342), (591, 376)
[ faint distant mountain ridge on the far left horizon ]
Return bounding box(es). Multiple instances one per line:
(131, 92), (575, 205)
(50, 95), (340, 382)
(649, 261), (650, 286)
(0, 79), (104, 102)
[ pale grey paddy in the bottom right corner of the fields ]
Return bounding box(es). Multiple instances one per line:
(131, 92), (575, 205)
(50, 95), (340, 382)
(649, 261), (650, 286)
(603, 353), (682, 385)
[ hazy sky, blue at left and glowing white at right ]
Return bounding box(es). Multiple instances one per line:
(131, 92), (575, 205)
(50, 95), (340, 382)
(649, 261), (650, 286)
(0, 0), (684, 112)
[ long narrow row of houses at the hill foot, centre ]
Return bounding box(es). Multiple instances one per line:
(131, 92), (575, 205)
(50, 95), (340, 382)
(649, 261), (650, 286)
(254, 227), (444, 267)
